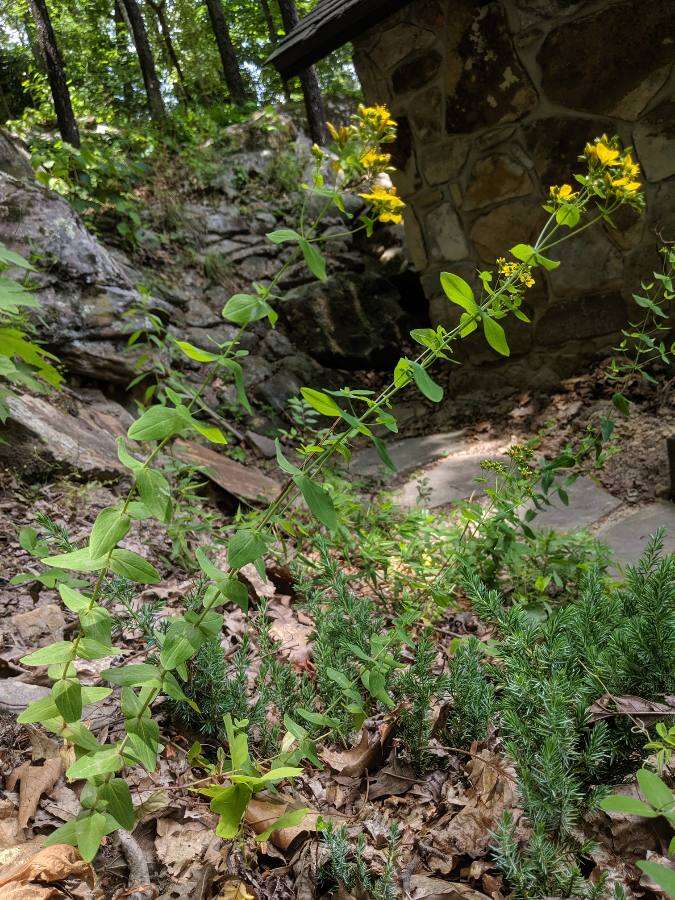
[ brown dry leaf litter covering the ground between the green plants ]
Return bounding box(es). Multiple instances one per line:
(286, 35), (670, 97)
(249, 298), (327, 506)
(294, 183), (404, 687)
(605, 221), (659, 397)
(0, 354), (674, 900)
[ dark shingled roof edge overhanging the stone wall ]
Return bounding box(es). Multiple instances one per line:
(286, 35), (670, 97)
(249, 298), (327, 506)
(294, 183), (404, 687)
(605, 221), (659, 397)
(268, 0), (412, 78)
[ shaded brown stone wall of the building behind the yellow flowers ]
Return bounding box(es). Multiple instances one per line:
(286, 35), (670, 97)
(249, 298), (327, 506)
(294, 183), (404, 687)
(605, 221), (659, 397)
(355, 0), (675, 394)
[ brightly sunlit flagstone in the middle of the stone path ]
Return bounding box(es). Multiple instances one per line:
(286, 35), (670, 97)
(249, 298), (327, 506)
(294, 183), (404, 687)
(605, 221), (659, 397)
(394, 452), (506, 509)
